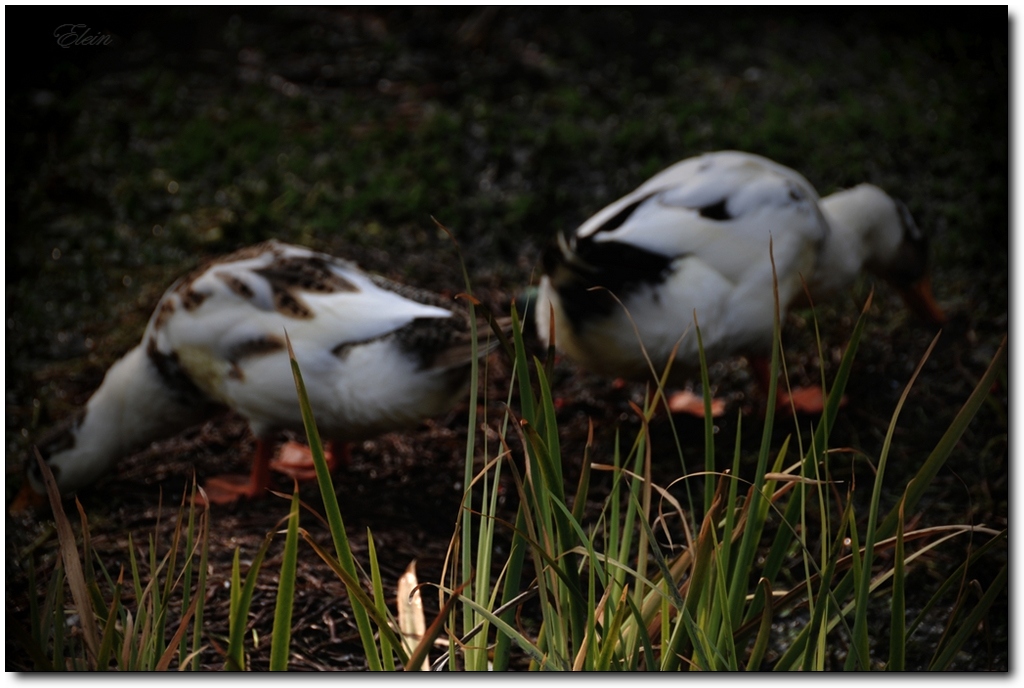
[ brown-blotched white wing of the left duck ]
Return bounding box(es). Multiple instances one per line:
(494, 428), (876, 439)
(144, 242), (462, 401)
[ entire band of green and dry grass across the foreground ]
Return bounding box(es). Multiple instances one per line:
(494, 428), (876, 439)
(19, 284), (1008, 671)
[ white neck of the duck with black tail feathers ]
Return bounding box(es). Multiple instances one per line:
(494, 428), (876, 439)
(812, 184), (903, 298)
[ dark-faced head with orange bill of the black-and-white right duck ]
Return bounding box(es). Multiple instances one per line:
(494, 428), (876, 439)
(821, 184), (946, 326)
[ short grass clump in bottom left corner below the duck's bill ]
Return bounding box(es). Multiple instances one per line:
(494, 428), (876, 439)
(15, 456), (210, 671)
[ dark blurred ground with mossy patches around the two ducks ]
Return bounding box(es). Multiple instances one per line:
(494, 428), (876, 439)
(5, 7), (1010, 671)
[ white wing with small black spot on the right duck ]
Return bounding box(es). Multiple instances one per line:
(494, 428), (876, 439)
(570, 152), (828, 283)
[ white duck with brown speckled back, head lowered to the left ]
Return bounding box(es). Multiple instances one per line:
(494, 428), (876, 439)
(18, 241), (486, 503)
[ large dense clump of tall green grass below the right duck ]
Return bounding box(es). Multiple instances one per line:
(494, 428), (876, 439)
(428, 294), (1007, 671)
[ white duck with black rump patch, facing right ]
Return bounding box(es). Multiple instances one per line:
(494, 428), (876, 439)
(536, 152), (944, 415)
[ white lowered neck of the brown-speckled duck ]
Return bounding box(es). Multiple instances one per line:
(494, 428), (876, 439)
(42, 345), (201, 493)
